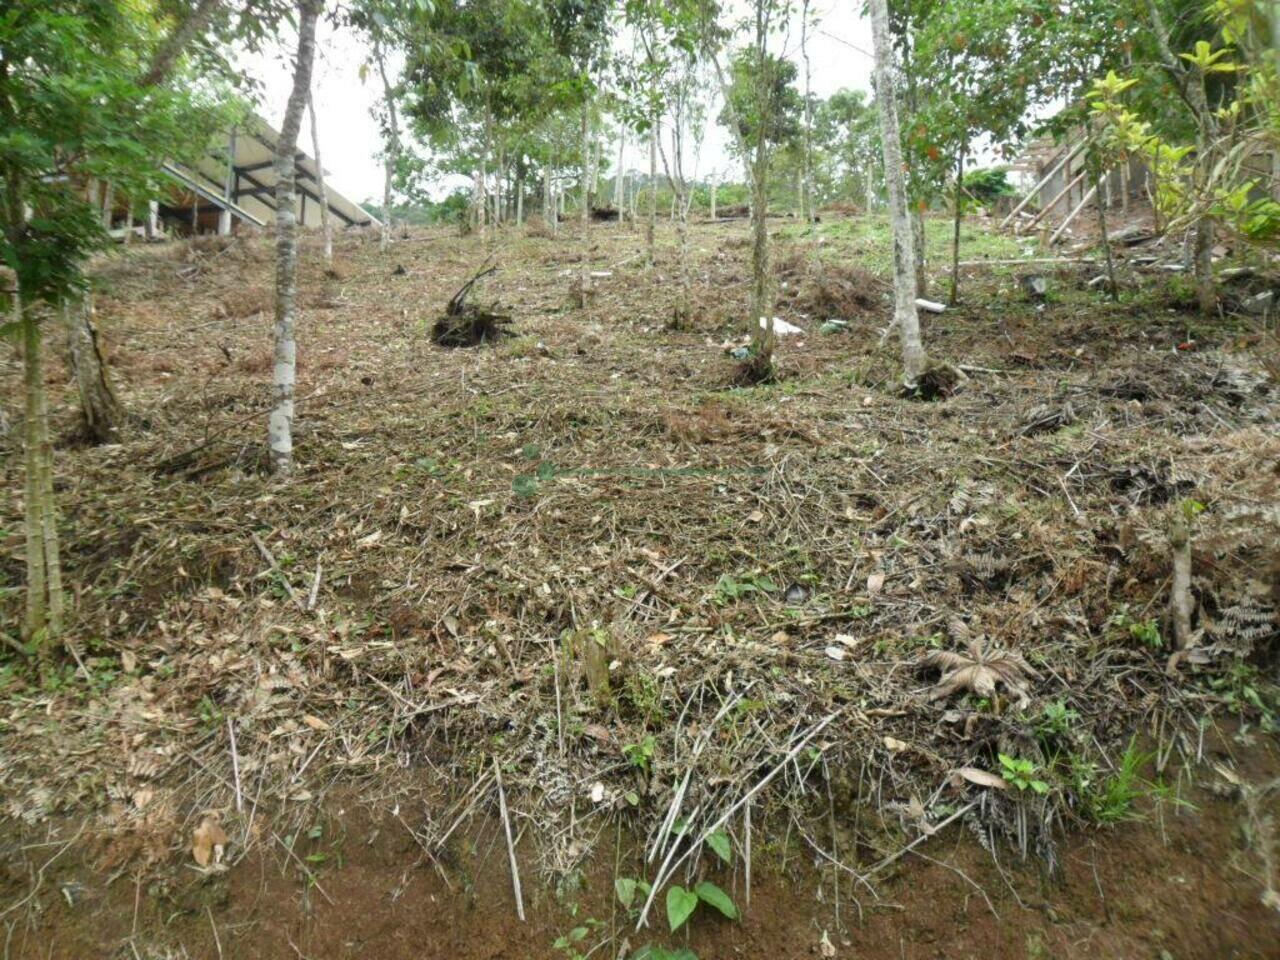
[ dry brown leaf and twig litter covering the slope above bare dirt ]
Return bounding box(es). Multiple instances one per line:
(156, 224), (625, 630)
(0, 221), (1280, 906)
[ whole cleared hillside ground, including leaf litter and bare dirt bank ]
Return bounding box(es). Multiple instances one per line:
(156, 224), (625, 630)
(0, 218), (1280, 957)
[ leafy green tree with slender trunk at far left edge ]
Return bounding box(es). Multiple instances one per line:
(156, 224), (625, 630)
(0, 0), (241, 643)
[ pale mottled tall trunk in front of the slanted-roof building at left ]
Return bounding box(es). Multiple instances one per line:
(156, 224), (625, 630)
(268, 0), (320, 474)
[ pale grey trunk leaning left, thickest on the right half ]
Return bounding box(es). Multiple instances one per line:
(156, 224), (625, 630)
(870, 0), (928, 390)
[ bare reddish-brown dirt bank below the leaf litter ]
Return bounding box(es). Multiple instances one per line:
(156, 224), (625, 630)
(0, 741), (1280, 960)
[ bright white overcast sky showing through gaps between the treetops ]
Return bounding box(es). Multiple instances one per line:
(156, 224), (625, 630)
(242, 0), (872, 204)
